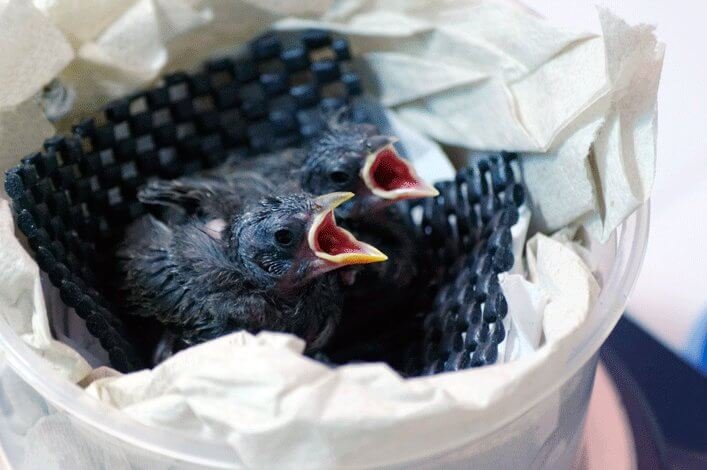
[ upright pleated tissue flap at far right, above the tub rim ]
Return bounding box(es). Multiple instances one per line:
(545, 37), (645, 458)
(523, 10), (665, 242)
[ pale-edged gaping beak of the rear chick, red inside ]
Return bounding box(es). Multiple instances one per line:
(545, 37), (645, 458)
(361, 137), (439, 201)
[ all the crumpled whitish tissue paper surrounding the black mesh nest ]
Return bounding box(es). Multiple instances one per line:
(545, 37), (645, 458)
(0, 0), (663, 467)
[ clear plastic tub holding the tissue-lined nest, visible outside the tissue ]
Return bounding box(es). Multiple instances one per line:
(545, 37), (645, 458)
(0, 204), (649, 470)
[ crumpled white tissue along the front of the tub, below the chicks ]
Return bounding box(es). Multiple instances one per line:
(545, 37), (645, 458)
(87, 222), (598, 468)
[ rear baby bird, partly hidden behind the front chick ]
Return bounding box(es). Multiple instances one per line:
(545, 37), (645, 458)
(139, 120), (438, 218)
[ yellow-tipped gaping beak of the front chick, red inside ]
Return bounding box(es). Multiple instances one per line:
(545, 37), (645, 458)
(307, 193), (388, 270)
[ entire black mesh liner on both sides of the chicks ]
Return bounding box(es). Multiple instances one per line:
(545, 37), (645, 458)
(5, 30), (523, 374)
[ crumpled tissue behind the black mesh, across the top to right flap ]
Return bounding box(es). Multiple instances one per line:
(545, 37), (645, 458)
(24, 0), (664, 241)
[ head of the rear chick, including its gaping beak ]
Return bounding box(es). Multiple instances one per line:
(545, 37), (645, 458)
(301, 123), (438, 217)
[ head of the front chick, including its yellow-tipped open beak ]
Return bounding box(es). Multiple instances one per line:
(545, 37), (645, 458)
(230, 192), (387, 291)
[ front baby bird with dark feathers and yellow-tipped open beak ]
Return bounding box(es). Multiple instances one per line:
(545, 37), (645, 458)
(118, 192), (387, 352)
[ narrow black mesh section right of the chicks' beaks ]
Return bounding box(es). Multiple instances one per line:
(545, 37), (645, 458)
(407, 153), (525, 375)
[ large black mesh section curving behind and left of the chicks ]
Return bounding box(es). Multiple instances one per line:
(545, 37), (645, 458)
(5, 30), (365, 372)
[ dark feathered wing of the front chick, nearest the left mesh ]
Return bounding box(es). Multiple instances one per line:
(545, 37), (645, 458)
(117, 215), (246, 330)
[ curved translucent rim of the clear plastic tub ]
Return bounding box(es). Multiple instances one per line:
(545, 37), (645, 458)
(0, 201), (650, 468)
